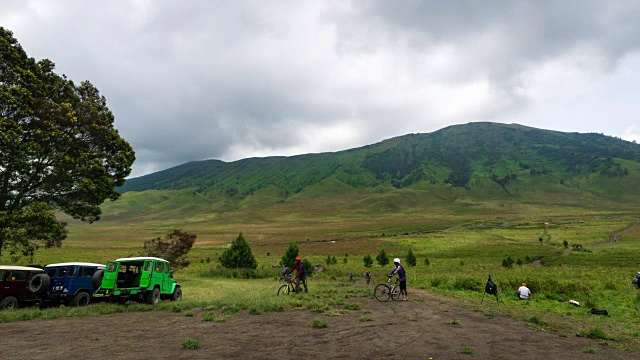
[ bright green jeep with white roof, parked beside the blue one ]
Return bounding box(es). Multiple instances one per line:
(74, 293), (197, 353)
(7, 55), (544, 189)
(93, 257), (182, 305)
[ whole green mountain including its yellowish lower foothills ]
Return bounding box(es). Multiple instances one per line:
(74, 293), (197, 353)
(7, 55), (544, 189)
(103, 122), (640, 225)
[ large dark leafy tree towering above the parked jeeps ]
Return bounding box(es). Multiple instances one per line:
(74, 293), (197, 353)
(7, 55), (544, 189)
(0, 27), (135, 256)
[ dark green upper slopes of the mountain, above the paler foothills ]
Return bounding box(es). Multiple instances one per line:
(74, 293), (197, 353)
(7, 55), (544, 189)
(120, 123), (640, 197)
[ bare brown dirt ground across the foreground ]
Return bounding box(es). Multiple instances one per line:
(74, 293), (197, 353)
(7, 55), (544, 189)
(0, 291), (640, 360)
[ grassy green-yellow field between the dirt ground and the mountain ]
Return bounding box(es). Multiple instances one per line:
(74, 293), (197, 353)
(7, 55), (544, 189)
(0, 208), (640, 347)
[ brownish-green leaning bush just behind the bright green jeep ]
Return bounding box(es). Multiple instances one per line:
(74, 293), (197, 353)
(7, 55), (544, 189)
(141, 229), (198, 269)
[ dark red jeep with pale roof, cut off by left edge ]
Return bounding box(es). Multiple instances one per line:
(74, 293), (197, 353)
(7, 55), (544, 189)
(0, 265), (43, 310)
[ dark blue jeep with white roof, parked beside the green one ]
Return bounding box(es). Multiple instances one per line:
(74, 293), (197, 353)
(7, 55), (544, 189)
(29, 262), (108, 308)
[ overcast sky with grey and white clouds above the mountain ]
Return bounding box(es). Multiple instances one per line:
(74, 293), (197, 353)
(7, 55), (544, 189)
(0, 0), (640, 176)
